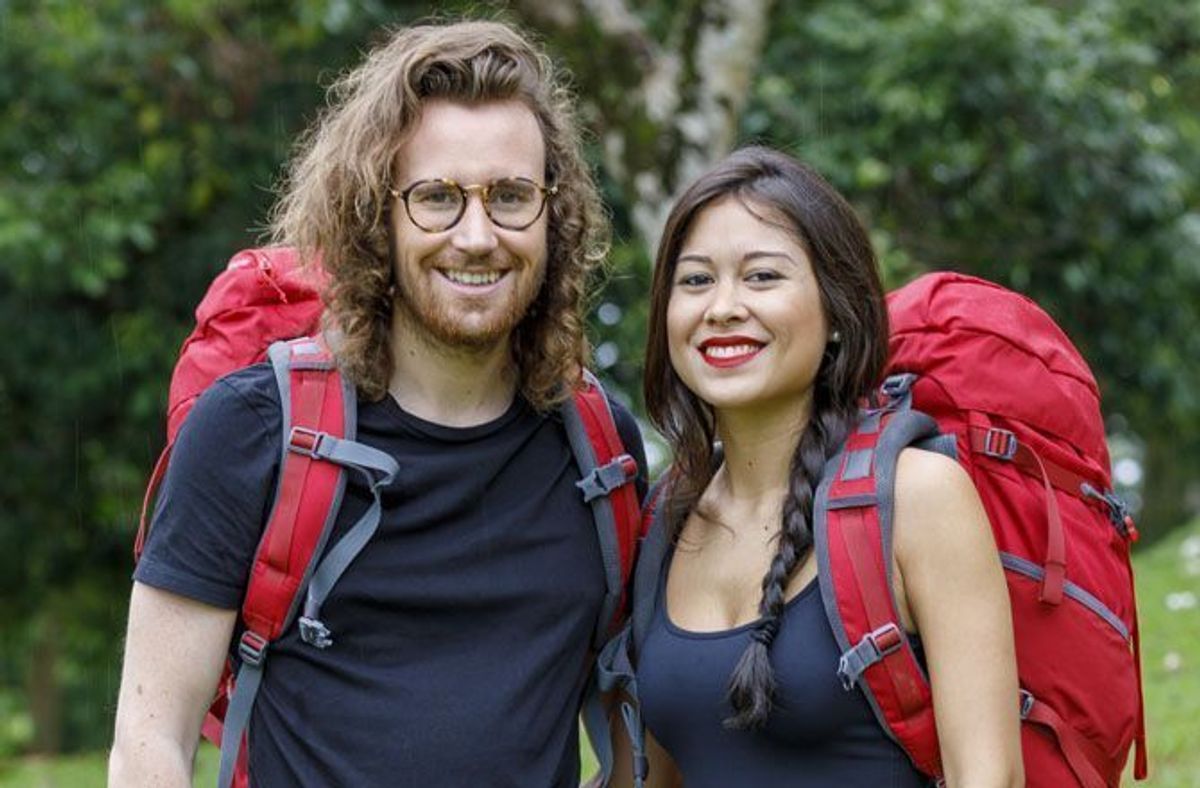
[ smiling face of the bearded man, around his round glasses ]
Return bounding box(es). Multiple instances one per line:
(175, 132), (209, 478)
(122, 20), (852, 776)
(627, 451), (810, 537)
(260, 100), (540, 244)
(391, 101), (552, 350)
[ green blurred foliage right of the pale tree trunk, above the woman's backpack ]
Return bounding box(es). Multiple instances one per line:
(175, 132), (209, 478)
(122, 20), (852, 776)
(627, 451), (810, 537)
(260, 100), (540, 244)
(743, 0), (1200, 533)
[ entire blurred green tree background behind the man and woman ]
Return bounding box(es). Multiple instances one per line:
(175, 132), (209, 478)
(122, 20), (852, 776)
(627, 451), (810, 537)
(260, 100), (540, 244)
(0, 0), (1200, 758)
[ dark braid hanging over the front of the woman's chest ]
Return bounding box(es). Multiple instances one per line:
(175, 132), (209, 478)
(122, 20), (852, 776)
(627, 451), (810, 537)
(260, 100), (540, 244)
(725, 409), (853, 728)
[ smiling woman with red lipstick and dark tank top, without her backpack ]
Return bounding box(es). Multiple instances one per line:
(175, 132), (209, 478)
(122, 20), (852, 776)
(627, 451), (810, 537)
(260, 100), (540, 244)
(614, 148), (1022, 788)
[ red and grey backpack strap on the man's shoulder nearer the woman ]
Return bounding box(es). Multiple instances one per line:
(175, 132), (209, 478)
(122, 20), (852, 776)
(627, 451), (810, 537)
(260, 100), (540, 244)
(560, 371), (641, 649)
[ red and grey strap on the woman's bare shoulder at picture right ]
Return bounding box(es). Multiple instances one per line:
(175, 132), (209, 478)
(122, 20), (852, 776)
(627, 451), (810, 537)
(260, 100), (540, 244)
(814, 409), (941, 777)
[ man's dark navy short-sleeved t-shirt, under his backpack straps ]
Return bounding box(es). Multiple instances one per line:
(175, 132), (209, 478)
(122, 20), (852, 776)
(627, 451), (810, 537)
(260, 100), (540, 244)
(134, 365), (646, 787)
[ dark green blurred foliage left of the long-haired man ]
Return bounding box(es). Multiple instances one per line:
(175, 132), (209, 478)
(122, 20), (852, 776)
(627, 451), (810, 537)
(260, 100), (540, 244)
(0, 0), (427, 752)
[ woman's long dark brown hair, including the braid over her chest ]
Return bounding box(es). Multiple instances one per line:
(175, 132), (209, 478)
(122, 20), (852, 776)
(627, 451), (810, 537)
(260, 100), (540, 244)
(644, 148), (888, 728)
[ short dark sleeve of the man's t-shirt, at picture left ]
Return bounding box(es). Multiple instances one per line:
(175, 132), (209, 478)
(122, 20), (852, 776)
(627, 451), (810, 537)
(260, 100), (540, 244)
(133, 365), (282, 609)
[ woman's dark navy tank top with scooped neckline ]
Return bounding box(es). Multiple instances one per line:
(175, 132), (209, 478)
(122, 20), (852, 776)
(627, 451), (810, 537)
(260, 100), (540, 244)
(637, 557), (929, 788)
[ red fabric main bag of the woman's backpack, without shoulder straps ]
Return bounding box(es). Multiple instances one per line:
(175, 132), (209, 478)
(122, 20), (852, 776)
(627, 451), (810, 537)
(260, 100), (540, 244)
(888, 273), (1145, 788)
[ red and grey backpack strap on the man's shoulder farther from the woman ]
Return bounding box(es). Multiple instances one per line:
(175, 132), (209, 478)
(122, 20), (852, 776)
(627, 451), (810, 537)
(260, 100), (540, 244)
(217, 338), (397, 788)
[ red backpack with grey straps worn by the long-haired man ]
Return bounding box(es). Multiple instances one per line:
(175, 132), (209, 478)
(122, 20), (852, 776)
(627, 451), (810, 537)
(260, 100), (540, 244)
(134, 248), (640, 787)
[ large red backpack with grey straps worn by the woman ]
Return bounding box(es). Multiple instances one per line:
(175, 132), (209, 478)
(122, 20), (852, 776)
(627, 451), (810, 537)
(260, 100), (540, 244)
(614, 273), (1147, 788)
